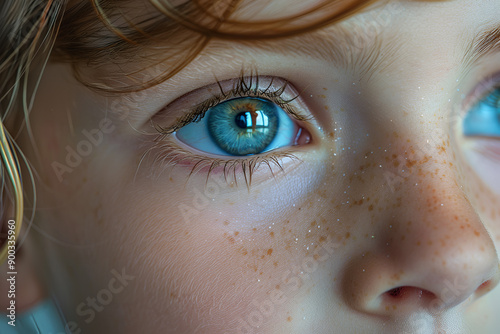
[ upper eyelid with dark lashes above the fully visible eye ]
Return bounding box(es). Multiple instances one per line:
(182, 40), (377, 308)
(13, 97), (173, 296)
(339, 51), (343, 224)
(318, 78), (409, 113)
(151, 75), (313, 135)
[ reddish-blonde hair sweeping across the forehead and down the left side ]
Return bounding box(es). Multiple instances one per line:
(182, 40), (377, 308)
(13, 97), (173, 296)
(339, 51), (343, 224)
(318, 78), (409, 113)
(0, 0), (376, 263)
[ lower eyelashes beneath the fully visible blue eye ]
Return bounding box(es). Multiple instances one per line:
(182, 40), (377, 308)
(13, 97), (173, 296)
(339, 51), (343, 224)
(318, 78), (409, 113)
(136, 136), (302, 189)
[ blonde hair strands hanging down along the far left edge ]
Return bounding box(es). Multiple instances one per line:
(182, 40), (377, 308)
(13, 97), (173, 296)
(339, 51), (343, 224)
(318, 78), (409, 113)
(0, 0), (64, 263)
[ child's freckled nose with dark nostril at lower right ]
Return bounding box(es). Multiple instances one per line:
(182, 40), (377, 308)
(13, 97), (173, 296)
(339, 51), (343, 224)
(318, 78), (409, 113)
(343, 155), (499, 316)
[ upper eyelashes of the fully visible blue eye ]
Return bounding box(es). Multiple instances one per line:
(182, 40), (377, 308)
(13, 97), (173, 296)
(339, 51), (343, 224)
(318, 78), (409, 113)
(153, 72), (311, 137)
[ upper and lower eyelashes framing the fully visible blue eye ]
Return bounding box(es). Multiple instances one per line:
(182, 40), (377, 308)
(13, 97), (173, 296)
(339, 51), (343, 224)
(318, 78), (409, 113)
(141, 72), (312, 189)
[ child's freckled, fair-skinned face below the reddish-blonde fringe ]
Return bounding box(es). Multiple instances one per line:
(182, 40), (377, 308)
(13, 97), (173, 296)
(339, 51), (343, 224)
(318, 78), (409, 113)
(27, 0), (500, 333)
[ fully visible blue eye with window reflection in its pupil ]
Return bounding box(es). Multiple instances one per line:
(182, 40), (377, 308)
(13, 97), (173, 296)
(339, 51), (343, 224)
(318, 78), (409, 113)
(175, 97), (298, 156)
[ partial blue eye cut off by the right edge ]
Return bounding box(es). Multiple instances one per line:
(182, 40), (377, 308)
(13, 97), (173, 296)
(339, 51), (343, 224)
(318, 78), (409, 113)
(463, 88), (500, 137)
